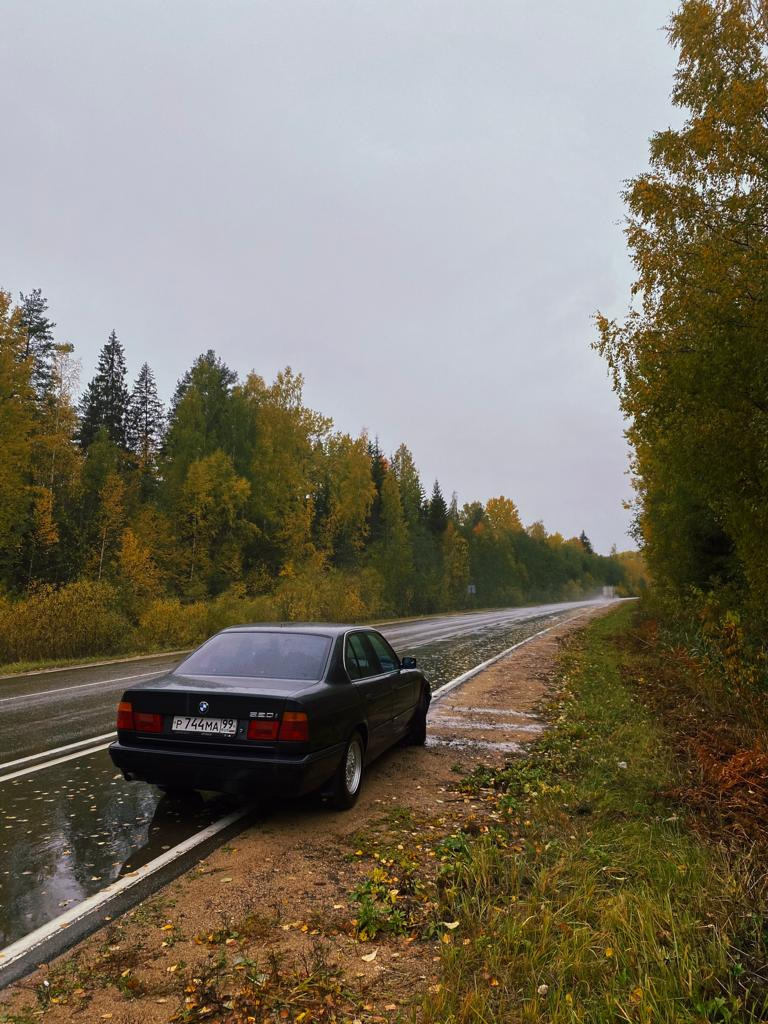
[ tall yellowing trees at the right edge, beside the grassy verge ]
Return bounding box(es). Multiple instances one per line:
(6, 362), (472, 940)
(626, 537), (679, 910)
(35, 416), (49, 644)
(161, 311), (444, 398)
(598, 0), (768, 671)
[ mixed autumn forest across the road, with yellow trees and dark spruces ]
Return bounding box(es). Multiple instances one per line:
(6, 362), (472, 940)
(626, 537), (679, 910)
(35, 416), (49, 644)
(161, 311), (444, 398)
(0, 290), (639, 660)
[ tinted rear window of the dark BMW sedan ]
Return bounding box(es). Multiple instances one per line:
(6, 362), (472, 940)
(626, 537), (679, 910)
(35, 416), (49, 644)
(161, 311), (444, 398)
(175, 631), (331, 680)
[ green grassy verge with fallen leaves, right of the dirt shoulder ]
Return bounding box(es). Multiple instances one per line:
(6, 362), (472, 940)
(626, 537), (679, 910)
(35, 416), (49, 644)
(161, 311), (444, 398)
(424, 608), (768, 1024)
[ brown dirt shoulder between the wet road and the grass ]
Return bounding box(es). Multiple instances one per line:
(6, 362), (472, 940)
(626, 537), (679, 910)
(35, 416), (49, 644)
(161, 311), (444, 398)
(0, 608), (614, 1024)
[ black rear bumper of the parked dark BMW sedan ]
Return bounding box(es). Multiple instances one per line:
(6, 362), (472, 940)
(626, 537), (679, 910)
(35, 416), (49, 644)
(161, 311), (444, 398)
(110, 740), (344, 799)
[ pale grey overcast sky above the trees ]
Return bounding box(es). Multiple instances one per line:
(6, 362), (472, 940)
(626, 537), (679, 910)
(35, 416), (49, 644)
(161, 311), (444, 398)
(0, 0), (676, 551)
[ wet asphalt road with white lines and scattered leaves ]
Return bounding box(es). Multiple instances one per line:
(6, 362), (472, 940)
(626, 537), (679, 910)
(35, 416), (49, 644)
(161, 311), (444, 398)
(0, 602), (606, 948)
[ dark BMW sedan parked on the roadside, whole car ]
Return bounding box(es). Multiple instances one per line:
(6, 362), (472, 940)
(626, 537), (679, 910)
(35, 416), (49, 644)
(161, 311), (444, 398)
(110, 625), (430, 808)
